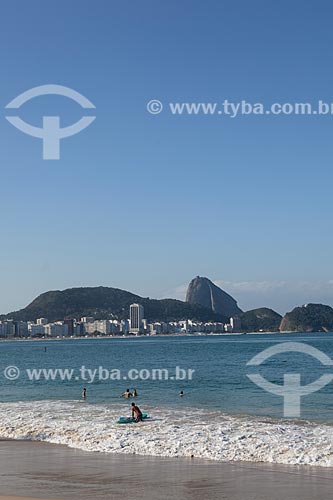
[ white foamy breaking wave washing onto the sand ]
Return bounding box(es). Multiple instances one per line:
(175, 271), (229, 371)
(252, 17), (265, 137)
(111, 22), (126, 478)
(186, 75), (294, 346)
(0, 401), (333, 467)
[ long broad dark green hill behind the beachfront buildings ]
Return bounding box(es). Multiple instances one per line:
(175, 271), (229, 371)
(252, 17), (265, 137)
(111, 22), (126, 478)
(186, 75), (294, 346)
(0, 287), (226, 321)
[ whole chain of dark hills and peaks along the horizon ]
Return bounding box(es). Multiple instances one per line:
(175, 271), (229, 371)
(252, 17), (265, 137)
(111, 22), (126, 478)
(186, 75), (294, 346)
(0, 276), (333, 336)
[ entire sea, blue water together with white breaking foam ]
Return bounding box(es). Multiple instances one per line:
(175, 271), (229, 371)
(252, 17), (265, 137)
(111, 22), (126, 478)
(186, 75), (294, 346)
(0, 333), (333, 466)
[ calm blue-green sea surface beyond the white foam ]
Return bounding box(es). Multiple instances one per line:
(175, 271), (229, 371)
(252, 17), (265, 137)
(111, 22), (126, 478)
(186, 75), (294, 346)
(0, 333), (333, 423)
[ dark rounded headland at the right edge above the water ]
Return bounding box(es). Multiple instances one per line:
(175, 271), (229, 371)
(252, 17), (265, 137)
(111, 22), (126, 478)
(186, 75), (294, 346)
(280, 304), (333, 332)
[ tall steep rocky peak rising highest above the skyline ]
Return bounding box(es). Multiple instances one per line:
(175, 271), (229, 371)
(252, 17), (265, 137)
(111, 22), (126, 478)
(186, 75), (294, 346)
(186, 276), (243, 318)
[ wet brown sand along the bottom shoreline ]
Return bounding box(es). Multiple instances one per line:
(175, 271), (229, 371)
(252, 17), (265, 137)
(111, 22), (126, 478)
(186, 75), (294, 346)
(0, 441), (333, 500)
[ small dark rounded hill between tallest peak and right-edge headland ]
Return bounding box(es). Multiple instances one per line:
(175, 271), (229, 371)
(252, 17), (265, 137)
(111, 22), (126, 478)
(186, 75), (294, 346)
(240, 307), (282, 332)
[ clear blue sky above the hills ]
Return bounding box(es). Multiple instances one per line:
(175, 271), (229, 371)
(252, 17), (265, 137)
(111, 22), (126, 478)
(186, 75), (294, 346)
(0, 0), (333, 312)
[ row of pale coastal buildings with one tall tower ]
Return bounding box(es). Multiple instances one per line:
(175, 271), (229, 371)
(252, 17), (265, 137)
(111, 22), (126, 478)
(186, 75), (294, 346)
(0, 304), (241, 338)
